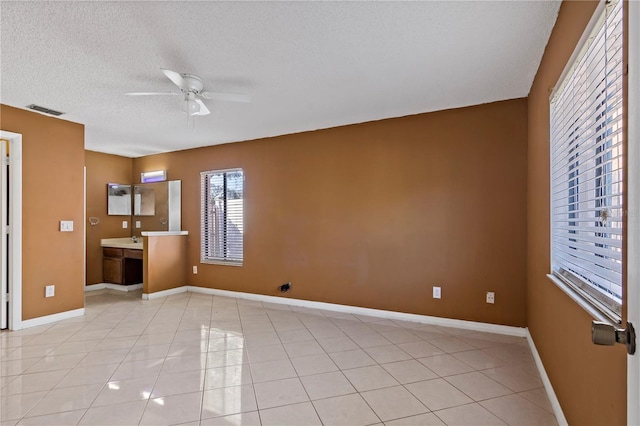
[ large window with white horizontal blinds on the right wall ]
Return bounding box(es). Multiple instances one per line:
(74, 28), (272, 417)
(550, 1), (624, 321)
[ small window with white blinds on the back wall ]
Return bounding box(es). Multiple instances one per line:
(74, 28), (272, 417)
(200, 169), (244, 266)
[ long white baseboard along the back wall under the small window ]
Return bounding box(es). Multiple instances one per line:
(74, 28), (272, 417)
(185, 286), (526, 337)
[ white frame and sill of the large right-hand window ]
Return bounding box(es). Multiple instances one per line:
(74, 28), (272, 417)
(547, 0), (627, 324)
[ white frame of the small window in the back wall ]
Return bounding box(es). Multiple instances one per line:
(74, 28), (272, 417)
(200, 167), (246, 266)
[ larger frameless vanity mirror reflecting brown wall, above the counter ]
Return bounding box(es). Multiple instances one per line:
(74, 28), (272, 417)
(132, 180), (182, 236)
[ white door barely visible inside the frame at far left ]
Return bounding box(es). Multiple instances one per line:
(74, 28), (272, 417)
(0, 139), (9, 329)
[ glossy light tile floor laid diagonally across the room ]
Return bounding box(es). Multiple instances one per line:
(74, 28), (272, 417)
(0, 291), (556, 426)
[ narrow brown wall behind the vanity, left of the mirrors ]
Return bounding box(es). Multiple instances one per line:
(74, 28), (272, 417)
(84, 151), (133, 285)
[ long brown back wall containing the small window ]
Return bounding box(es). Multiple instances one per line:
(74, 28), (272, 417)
(133, 99), (527, 326)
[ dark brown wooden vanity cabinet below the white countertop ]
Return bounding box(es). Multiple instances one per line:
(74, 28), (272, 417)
(102, 247), (142, 285)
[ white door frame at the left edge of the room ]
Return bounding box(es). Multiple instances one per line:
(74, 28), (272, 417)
(0, 130), (22, 330)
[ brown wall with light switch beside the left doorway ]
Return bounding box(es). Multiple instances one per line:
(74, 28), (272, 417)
(0, 105), (84, 320)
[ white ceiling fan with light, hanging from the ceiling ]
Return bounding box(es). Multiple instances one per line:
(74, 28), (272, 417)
(126, 68), (251, 116)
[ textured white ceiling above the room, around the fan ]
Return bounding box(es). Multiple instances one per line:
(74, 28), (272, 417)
(0, 0), (560, 157)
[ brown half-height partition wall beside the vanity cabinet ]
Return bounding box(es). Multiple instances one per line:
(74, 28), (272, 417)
(142, 235), (187, 294)
